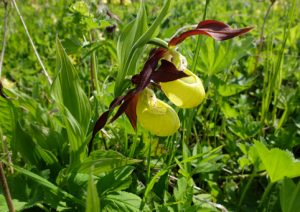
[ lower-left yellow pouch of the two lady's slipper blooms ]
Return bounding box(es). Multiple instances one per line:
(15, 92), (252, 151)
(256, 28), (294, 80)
(136, 88), (180, 136)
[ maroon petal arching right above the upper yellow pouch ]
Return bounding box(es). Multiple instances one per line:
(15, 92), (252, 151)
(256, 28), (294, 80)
(169, 20), (252, 46)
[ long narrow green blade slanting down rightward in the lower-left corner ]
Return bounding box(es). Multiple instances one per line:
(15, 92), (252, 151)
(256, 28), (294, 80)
(13, 165), (84, 205)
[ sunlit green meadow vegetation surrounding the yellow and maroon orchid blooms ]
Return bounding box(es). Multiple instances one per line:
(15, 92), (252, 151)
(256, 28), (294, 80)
(0, 0), (300, 212)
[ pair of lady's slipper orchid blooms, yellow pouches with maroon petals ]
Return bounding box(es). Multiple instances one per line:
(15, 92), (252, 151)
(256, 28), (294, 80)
(89, 20), (252, 152)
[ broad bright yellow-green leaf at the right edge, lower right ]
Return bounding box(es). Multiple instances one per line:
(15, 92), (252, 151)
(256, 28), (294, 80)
(255, 141), (300, 182)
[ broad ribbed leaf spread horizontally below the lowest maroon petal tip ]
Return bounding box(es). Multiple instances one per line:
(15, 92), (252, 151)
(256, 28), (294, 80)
(70, 150), (140, 175)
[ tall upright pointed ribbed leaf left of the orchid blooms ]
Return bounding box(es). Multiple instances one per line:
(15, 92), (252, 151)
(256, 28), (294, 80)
(52, 38), (91, 163)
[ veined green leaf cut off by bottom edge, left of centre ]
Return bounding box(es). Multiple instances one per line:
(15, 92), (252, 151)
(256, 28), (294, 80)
(101, 191), (142, 212)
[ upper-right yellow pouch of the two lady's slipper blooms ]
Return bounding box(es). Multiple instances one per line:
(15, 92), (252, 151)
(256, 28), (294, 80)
(160, 69), (205, 108)
